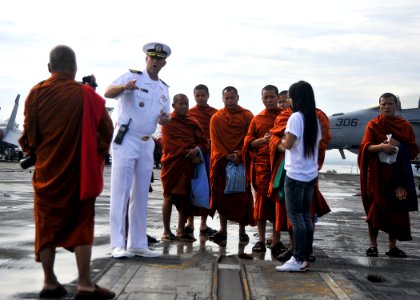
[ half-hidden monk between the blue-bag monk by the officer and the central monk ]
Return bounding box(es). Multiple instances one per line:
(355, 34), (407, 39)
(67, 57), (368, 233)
(185, 84), (217, 238)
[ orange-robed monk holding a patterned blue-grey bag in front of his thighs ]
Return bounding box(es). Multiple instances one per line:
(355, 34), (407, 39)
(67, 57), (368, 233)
(210, 86), (254, 246)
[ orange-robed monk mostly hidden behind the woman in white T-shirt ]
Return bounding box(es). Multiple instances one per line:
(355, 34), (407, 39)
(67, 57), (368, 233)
(268, 92), (331, 262)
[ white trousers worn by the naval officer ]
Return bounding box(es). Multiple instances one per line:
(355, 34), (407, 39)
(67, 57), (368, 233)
(110, 132), (154, 249)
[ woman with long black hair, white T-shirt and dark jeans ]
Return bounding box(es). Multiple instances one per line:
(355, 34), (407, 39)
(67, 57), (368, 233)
(276, 81), (321, 271)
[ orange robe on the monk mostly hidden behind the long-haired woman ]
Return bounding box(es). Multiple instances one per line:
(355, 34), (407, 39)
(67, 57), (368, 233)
(268, 108), (331, 231)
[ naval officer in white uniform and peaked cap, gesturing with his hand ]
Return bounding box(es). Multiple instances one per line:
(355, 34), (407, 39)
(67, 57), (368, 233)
(105, 43), (171, 258)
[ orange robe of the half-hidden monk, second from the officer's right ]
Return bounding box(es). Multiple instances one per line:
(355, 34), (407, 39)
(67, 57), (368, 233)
(188, 105), (217, 217)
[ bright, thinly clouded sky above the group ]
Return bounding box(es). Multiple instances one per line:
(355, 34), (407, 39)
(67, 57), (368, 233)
(0, 0), (420, 164)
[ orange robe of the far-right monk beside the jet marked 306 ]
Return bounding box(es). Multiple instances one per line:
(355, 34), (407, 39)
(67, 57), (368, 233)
(358, 115), (419, 241)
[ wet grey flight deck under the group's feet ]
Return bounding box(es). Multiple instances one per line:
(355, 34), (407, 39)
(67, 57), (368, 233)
(0, 163), (420, 299)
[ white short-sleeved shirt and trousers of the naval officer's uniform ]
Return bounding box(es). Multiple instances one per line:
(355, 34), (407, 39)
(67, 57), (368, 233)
(110, 70), (171, 250)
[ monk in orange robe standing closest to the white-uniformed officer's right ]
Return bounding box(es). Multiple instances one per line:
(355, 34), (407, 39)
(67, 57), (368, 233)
(161, 94), (209, 242)
